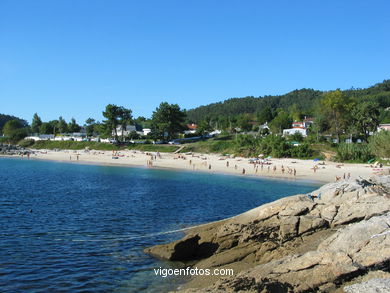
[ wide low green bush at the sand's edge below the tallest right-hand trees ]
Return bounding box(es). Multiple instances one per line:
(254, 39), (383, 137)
(337, 143), (374, 162)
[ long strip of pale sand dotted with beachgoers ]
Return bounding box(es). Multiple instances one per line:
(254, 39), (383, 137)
(9, 150), (390, 182)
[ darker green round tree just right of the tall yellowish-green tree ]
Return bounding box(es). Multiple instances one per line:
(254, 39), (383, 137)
(351, 102), (380, 141)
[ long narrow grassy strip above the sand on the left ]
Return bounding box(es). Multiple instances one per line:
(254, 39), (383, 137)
(19, 140), (179, 152)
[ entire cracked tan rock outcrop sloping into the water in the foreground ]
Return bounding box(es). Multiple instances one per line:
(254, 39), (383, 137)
(145, 176), (390, 292)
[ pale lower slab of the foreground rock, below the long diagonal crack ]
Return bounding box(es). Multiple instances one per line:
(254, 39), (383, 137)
(183, 213), (390, 292)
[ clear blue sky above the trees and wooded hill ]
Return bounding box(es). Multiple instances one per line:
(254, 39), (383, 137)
(0, 0), (390, 123)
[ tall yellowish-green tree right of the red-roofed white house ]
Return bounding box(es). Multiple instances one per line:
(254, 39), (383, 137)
(321, 90), (350, 141)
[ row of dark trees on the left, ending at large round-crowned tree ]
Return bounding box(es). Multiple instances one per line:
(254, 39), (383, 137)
(0, 102), (186, 142)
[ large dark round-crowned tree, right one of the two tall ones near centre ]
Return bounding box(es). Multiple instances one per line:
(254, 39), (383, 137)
(152, 102), (185, 140)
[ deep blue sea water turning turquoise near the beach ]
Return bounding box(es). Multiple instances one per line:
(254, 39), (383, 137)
(0, 158), (318, 292)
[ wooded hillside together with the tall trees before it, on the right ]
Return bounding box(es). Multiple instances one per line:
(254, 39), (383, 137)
(187, 80), (390, 141)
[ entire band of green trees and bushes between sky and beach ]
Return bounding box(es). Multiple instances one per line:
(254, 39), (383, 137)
(0, 80), (390, 162)
